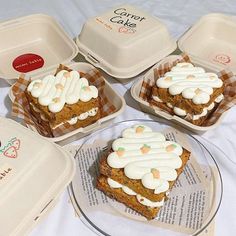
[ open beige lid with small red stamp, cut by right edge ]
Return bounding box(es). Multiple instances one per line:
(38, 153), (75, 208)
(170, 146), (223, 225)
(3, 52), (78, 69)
(178, 13), (236, 74)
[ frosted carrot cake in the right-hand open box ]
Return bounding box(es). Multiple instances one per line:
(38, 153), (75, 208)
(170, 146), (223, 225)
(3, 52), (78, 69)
(150, 62), (224, 125)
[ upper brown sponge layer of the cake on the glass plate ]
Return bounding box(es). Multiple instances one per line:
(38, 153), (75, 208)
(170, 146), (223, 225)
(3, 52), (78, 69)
(100, 149), (190, 201)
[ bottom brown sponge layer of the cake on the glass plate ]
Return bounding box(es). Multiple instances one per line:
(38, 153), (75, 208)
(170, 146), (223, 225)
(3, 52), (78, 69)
(97, 175), (160, 220)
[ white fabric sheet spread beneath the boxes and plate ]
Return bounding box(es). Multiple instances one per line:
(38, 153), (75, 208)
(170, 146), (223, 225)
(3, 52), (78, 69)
(0, 0), (236, 236)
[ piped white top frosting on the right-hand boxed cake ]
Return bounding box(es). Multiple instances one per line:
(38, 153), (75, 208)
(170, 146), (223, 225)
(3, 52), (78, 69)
(156, 63), (223, 104)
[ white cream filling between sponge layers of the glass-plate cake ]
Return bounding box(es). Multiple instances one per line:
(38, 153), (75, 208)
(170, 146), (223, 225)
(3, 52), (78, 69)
(107, 178), (164, 207)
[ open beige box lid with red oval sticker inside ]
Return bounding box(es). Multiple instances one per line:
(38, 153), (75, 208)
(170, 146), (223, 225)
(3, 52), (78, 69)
(0, 14), (78, 83)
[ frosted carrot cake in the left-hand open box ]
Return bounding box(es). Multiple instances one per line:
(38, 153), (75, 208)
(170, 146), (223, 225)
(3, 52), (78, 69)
(25, 70), (101, 133)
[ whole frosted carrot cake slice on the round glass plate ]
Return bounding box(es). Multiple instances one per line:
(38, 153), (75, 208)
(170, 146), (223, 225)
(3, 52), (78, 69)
(97, 125), (190, 220)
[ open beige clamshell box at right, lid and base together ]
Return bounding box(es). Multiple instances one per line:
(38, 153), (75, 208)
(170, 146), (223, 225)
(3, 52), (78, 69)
(131, 14), (236, 134)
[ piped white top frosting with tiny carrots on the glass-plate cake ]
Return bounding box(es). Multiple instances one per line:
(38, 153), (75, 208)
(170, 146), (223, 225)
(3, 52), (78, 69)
(107, 125), (183, 194)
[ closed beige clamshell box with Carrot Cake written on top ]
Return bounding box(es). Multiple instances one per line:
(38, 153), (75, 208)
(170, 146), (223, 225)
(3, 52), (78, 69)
(76, 5), (176, 81)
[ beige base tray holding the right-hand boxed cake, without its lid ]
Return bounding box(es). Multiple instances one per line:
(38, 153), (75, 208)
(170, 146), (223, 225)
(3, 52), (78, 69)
(131, 55), (225, 134)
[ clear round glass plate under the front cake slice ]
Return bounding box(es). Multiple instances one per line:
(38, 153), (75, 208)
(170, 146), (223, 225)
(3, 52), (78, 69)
(69, 119), (223, 236)
